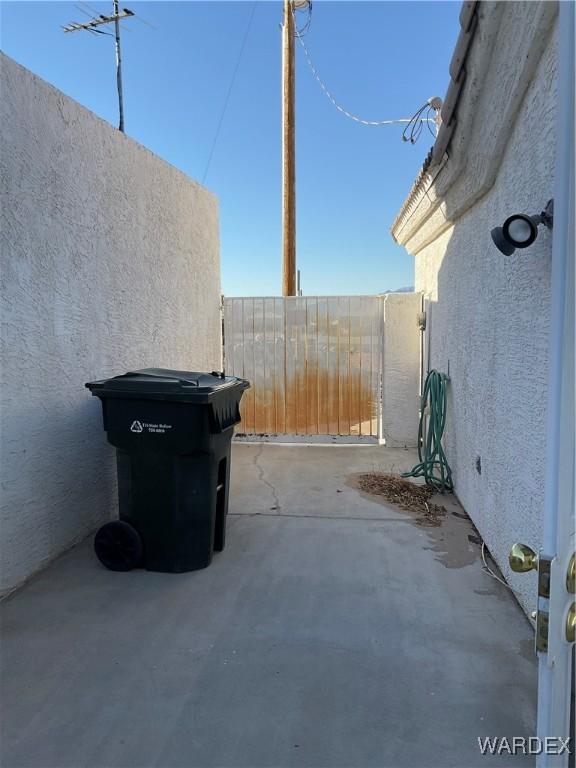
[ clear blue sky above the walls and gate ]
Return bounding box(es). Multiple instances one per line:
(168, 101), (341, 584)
(1, 0), (460, 296)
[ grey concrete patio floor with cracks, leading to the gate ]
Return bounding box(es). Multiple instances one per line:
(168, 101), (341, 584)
(1, 444), (536, 768)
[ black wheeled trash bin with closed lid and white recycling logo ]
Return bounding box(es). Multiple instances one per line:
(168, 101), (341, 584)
(86, 368), (250, 573)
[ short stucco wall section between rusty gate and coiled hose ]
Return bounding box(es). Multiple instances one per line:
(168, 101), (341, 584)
(382, 293), (422, 448)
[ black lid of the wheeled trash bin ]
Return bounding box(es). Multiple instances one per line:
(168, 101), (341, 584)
(86, 368), (250, 402)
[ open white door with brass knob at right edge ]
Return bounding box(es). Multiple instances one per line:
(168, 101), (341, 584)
(511, 2), (576, 768)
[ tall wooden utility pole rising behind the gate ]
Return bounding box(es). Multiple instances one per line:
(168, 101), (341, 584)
(282, 0), (296, 296)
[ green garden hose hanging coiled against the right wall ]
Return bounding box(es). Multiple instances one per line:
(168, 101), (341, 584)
(402, 370), (454, 492)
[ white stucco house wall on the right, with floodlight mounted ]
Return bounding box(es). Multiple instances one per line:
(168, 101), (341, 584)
(408, 18), (557, 612)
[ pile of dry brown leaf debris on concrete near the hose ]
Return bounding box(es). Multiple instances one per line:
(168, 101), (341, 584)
(357, 472), (446, 523)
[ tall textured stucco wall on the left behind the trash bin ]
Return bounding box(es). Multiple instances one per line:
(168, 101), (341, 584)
(0, 56), (221, 593)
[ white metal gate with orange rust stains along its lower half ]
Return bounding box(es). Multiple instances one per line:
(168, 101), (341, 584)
(224, 296), (383, 437)
